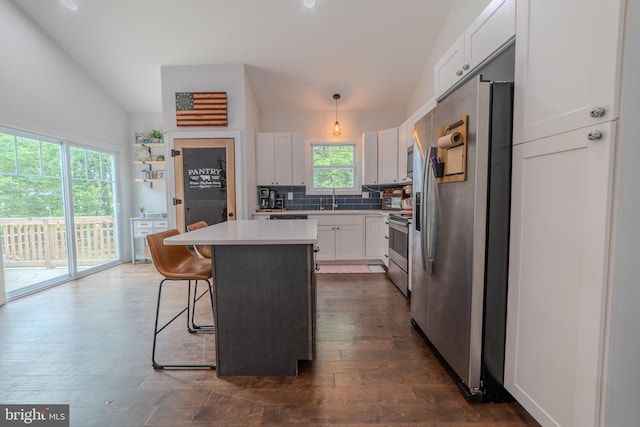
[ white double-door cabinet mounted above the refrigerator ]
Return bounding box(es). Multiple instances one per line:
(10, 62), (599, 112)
(434, 0), (516, 98)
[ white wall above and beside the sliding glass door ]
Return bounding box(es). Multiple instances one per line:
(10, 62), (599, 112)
(0, 0), (131, 295)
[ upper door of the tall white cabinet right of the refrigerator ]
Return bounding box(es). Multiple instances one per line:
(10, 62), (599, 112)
(514, 0), (622, 144)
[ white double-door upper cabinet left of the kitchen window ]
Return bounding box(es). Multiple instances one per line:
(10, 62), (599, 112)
(256, 132), (293, 185)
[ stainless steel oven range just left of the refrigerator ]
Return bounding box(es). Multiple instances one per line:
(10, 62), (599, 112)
(387, 214), (409, 297)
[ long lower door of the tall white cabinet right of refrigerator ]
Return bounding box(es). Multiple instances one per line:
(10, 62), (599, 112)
(505, 122), (615, 427)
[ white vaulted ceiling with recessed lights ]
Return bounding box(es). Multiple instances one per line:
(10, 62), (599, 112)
(12, 0), (452, 113)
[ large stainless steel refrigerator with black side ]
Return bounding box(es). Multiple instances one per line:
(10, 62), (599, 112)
(411, 77), (513, 401)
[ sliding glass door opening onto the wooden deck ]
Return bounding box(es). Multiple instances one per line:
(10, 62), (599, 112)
(0, 128), (119, 299)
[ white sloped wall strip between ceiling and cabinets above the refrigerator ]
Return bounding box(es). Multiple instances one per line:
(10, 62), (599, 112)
(405, 0), (491, 117)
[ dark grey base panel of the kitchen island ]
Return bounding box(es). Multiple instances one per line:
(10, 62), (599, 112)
(213, 245), (315, 376)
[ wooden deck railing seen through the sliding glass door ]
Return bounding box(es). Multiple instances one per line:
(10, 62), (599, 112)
(0, 216), (116, 268)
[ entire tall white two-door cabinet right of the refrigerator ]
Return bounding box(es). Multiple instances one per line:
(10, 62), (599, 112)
(505, 0), (622, 427)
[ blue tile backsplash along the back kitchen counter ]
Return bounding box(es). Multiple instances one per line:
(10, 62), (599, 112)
(256, 185), (402, 211)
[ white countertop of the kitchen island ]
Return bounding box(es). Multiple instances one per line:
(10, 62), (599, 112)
(164, 219), (318, 245)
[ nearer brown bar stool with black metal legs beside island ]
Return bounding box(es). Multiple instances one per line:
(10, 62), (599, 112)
(147, 229), (216, 369)
